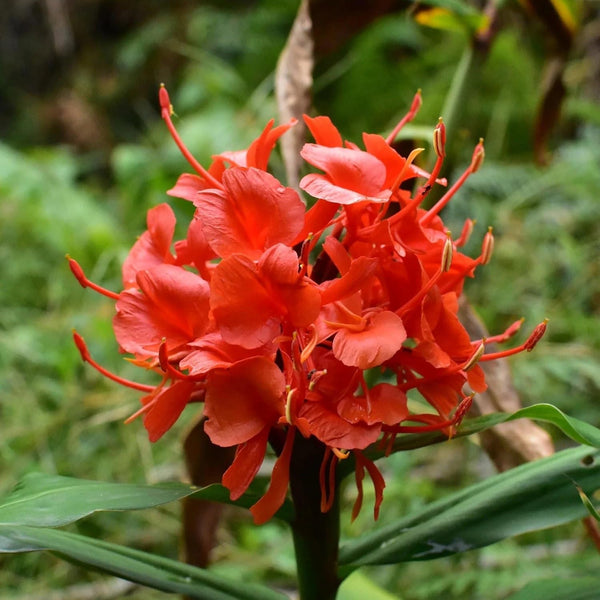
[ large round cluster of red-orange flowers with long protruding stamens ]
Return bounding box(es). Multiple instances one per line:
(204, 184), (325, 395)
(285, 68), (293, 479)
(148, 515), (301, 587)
(69, 87), (545, 523)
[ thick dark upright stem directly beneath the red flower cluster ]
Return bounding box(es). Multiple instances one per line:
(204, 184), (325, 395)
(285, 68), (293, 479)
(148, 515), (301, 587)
(290, 436), (340, 600)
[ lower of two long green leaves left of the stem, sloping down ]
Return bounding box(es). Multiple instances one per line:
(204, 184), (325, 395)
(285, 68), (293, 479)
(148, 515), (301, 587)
(0, 525), (285, 600)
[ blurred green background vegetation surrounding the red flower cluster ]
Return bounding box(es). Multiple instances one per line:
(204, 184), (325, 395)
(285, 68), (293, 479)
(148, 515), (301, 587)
(0, 0), (600, 600)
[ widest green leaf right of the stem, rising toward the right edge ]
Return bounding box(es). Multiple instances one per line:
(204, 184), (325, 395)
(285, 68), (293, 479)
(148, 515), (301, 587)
(340, 447), (600, 566)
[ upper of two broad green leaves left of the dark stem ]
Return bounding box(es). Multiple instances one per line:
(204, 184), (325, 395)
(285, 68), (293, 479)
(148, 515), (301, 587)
(0, 473), (293, 528)
